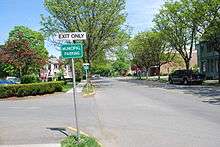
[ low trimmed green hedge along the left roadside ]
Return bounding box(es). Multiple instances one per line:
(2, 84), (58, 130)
(0, 81), (64, 98)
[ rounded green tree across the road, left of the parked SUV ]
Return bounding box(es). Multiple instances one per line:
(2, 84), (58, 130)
(129, 32), (175, 78)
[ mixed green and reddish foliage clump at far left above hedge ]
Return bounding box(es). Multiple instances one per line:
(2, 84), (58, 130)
(0, 26), (48, 77)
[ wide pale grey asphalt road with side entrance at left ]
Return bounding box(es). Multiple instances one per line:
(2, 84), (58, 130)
(0, 79), (220, 147)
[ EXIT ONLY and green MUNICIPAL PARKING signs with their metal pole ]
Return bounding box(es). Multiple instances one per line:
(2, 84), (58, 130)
(58, 32), (86, 141)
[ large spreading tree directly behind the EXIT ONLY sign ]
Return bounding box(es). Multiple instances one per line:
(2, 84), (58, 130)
(41, 0), (125, 65)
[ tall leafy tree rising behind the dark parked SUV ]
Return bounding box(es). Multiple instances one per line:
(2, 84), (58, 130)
(154, 0), (219, 69)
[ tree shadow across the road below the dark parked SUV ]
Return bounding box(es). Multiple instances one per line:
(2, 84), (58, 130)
(119, 79), (220, 105)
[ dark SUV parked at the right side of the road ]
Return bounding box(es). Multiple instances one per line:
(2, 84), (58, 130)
(168, 70), (205, 85)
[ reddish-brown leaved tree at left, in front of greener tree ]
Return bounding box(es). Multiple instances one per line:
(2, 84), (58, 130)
(0, 32), (46, 77)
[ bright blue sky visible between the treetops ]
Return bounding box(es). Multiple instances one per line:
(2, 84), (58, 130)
(0, 0), (163, 56)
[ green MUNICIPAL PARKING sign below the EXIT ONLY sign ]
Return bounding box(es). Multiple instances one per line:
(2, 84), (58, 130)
(61, 43), (83, 59)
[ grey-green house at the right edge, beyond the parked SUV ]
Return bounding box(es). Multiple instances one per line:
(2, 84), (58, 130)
(196, 41), (220, 79)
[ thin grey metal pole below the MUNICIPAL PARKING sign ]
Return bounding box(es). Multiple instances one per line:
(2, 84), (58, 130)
(72, 58), (79, 141)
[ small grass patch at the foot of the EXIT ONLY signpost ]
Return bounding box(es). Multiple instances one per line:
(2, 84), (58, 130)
(61, 135), (101, 147)
